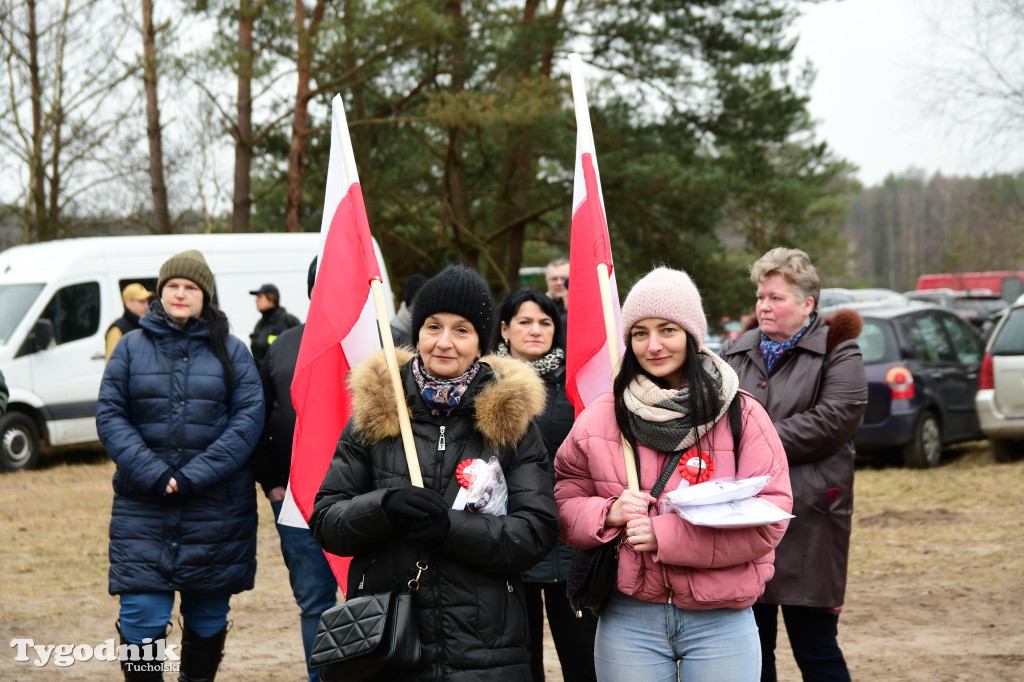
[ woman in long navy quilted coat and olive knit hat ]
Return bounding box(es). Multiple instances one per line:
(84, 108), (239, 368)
(96, 250), (263, 682)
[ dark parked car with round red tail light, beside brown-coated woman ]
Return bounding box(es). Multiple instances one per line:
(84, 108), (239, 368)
(846, 301), (984, 468)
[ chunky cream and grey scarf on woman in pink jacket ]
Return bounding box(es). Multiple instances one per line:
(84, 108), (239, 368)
(623, 348), (739, 453)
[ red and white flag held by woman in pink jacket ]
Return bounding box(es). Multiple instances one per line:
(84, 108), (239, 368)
(565, 54), (623, 417)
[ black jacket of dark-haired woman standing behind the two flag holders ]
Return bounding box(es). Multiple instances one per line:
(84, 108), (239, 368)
(522, 365), (575, 583)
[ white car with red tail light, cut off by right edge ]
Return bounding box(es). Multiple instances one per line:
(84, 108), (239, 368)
(975, 296), (1024, 462)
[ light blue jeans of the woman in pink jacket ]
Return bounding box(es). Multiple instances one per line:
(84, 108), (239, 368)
(594, 590), (761, 682)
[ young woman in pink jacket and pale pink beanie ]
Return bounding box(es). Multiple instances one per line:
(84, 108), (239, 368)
(555, 267), (793, 682)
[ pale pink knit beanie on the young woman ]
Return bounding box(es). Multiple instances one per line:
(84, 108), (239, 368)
(623, 267), (708, 347)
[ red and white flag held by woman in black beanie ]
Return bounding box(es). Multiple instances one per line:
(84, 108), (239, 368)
(289, 96), (381, 592)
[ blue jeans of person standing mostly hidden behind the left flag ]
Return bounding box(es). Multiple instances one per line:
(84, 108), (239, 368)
(270, 493), (338, 682)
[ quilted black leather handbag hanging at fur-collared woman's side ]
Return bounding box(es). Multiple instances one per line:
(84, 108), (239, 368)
(309, 561), (427, 682)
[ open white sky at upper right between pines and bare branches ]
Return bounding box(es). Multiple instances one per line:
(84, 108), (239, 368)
(796, 0), (1024, 186)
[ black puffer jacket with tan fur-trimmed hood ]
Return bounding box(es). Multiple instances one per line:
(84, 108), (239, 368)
(309, 350), (558, 682)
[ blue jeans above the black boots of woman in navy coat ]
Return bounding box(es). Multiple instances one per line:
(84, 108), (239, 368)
(120, 590), (231, 644)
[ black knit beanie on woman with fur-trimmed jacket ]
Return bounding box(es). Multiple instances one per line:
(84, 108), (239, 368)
(410, 265), (495, 352)
